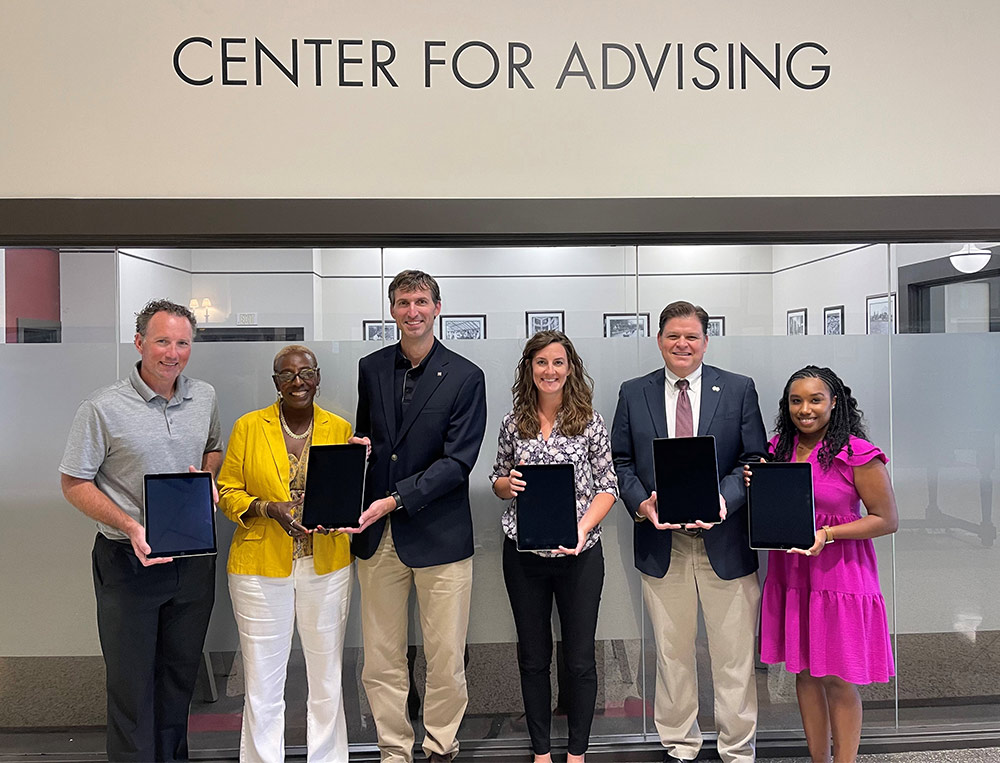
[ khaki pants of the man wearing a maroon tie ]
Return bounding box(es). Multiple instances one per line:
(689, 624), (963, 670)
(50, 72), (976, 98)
(642, 530), (760, 763)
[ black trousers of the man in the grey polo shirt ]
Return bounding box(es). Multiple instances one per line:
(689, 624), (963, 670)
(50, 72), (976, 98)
(93, 533), (215, 763)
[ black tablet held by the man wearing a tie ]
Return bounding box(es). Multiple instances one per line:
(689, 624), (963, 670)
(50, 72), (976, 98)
(653, 435), (720, 525)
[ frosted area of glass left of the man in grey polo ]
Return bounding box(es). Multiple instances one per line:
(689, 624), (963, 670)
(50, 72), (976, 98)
(0, 344), (120, 657)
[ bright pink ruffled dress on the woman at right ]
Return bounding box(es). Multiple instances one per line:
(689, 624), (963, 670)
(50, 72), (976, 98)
(760, 436), (896, 684)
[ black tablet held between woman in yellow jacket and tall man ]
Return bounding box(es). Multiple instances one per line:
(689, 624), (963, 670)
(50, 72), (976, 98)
(302, 443), (368, 530)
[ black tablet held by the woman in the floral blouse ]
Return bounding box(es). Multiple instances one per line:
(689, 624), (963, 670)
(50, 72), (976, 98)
(516, 464), (578, 551)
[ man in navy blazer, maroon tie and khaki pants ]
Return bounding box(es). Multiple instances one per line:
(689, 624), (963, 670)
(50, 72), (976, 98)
(611, 302), (767, 763)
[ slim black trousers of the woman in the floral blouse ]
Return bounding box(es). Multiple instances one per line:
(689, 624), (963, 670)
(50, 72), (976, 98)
(503, 538), (604, 755)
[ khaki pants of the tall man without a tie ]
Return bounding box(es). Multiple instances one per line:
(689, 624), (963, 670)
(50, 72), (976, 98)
(358, 520), (472, 763)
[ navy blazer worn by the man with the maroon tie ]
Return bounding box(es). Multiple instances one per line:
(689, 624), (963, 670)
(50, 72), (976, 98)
(611, 365), (767, 580)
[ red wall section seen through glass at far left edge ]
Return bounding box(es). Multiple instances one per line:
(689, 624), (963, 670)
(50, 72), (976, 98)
(4, 249), (59, 343)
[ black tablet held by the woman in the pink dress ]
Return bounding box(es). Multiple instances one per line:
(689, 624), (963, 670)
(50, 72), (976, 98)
(747, 462), (816, 549)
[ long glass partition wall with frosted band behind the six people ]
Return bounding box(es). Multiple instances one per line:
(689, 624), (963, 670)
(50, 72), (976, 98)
(0, 243), (1000, 757)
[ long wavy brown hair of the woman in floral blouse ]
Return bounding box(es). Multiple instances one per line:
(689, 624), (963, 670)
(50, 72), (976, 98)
(511, 331), (594, 440)
